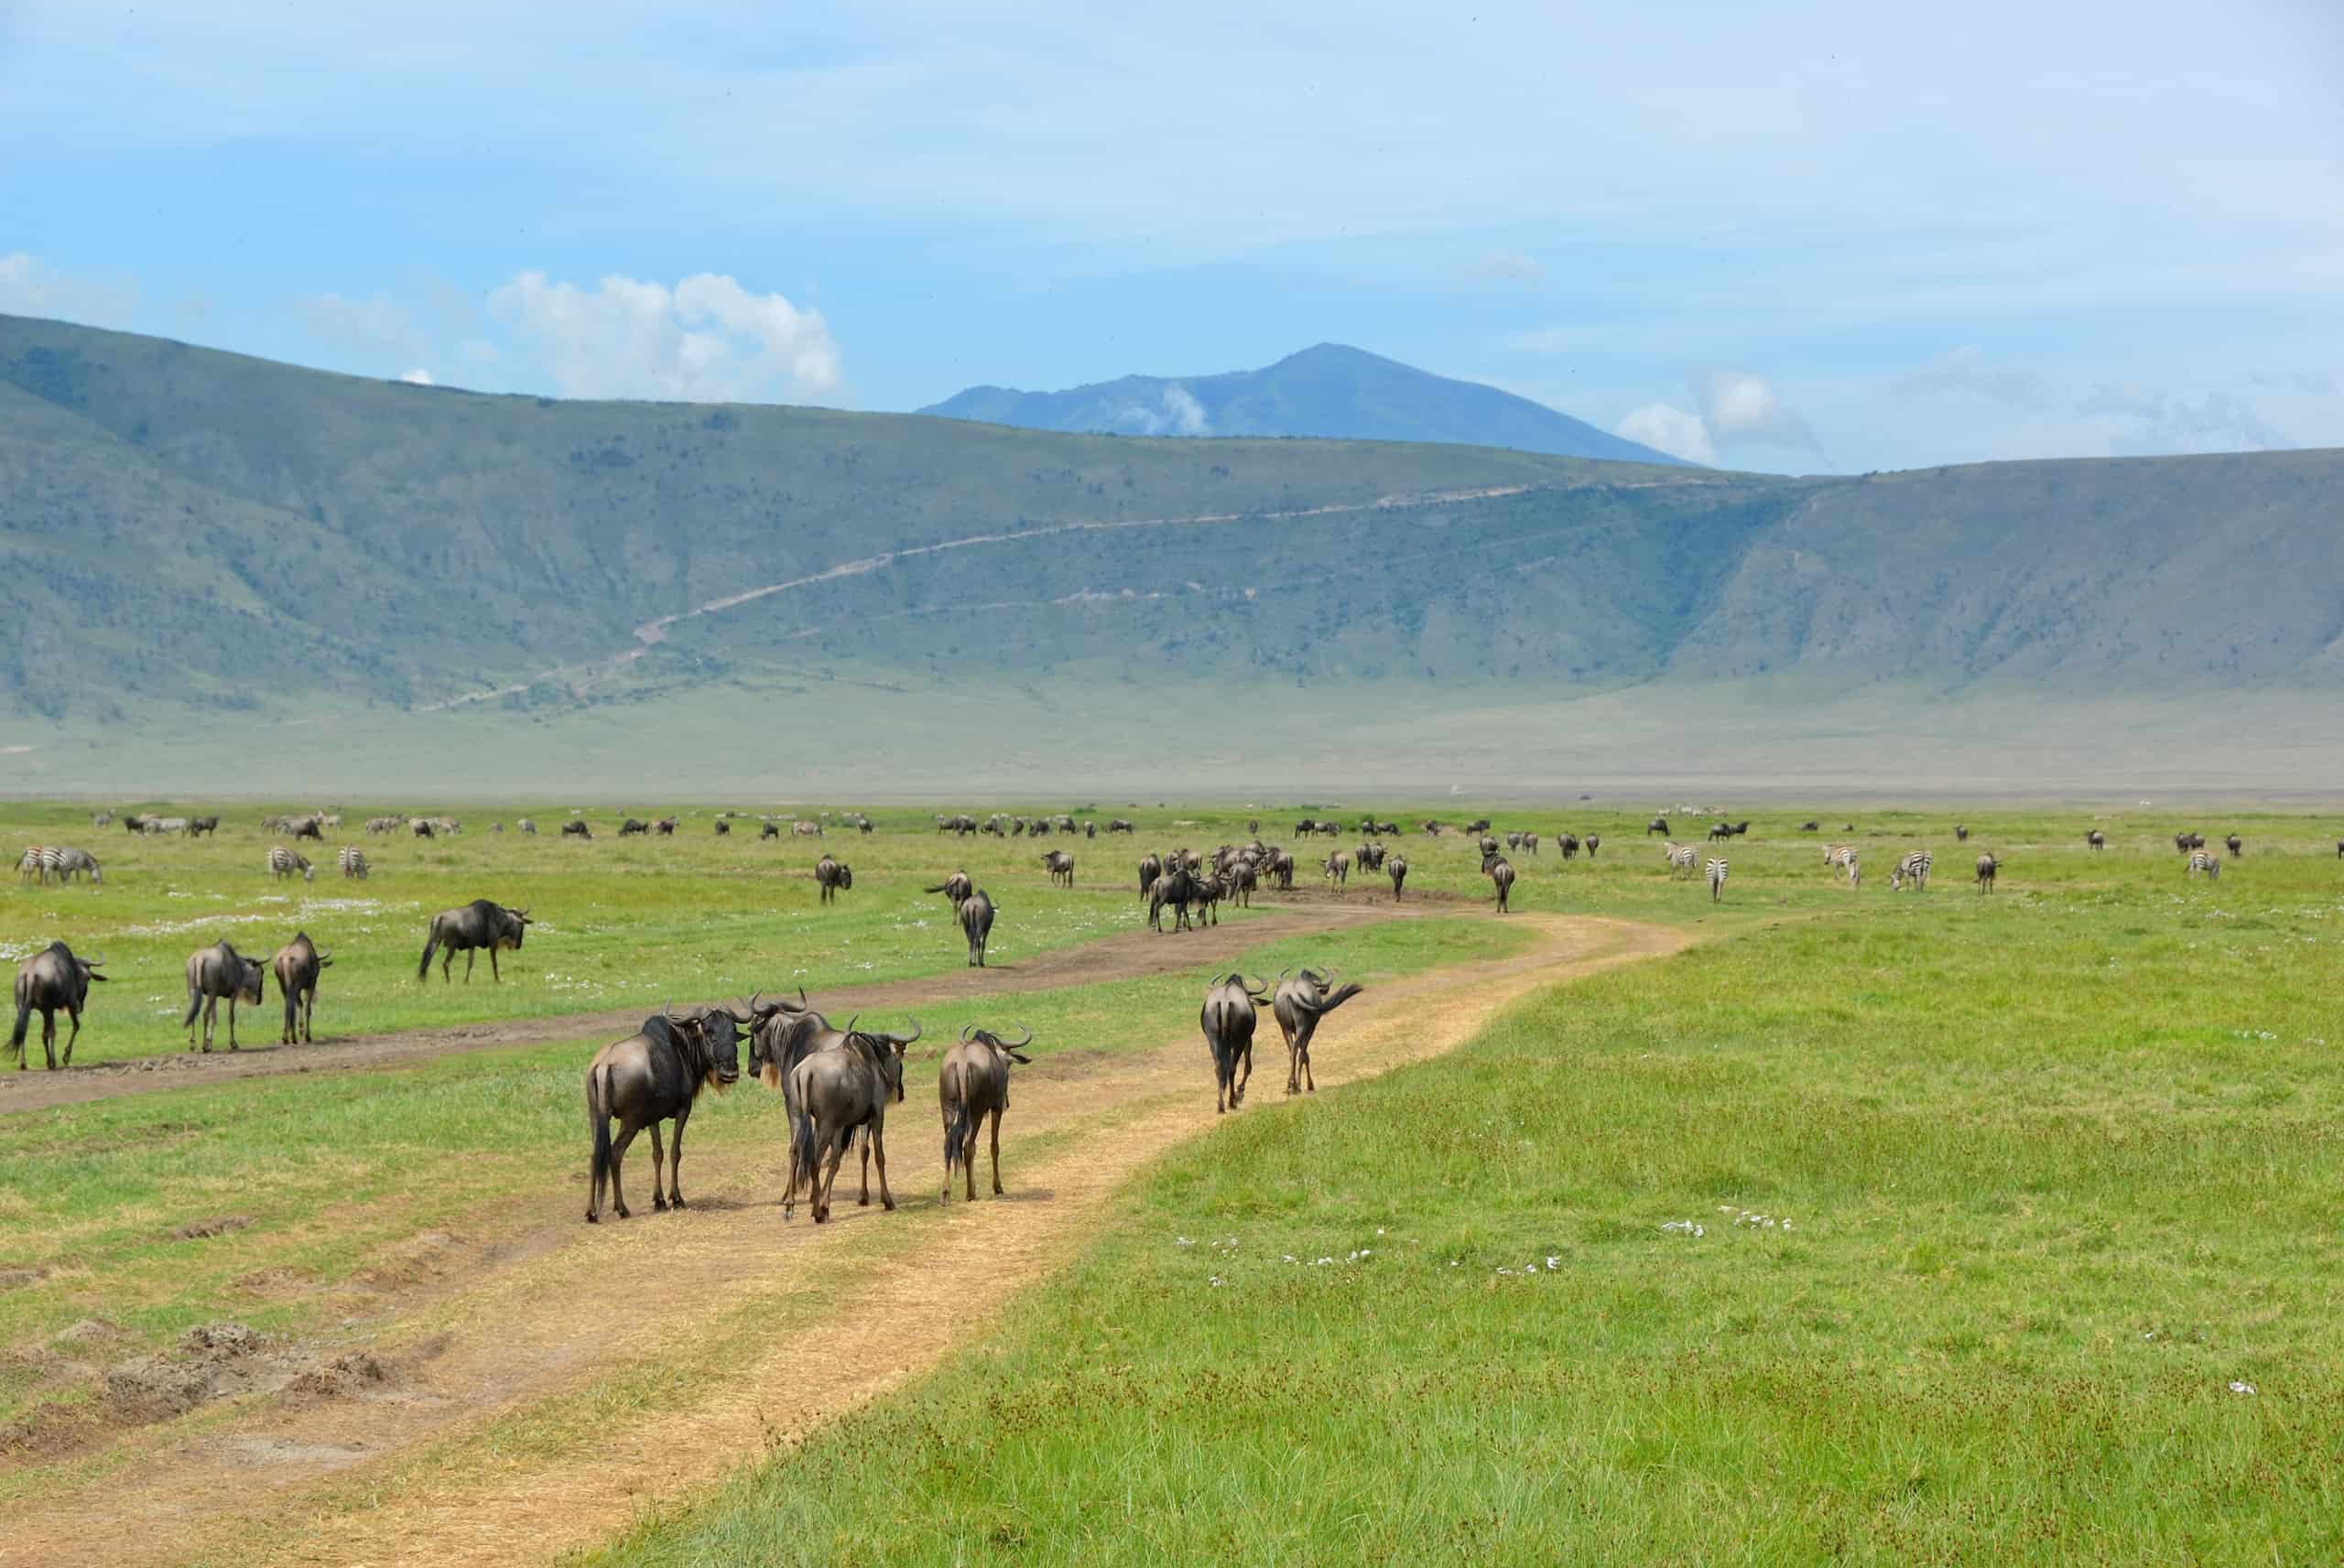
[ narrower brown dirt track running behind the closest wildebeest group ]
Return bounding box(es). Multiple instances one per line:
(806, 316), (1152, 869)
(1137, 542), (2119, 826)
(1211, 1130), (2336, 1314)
(0, 895), (1458, 1116)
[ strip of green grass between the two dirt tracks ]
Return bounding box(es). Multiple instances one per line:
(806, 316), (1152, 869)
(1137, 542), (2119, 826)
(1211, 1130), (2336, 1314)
(0, 916), (1519, 1444)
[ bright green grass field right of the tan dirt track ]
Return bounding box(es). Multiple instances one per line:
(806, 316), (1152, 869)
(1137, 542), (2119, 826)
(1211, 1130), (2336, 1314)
(576, 818), (2344, 1565)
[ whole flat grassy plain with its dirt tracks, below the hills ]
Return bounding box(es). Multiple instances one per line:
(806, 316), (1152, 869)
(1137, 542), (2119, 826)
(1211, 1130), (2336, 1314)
(0, 799), (2344, 1565)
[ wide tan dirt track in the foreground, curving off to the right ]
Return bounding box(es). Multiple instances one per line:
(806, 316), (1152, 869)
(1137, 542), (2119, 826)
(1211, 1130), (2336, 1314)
(0, 912), (1690, 1565)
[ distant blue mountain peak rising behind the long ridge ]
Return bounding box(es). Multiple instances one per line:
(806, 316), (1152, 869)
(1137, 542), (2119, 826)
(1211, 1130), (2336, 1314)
(919, 342), (1683, 467)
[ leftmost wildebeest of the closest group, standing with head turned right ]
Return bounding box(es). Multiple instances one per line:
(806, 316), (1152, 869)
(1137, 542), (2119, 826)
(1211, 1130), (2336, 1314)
(586, 996), (757, 1226)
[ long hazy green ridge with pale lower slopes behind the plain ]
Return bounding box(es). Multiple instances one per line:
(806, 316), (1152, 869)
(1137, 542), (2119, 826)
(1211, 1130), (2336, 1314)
(0, 317), (2344, 790)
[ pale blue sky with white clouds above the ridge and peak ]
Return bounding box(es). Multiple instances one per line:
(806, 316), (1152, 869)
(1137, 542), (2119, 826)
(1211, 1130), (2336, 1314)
(0, 0), (2344, 471)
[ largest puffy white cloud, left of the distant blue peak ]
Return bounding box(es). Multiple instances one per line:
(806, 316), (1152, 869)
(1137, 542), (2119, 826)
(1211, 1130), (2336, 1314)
(487, 272), (841, 403)
